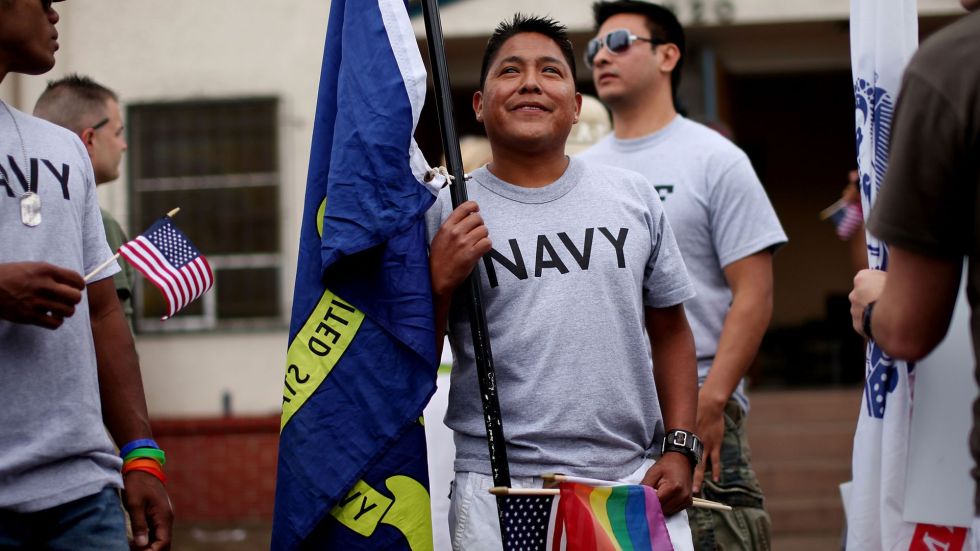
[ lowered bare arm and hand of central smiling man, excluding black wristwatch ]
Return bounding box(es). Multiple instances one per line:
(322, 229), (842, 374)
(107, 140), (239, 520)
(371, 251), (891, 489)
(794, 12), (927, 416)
(643, 304), (698, 515)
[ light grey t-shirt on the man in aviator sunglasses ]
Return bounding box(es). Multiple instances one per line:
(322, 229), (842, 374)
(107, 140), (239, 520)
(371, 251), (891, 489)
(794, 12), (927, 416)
(579, 115), (786, 410)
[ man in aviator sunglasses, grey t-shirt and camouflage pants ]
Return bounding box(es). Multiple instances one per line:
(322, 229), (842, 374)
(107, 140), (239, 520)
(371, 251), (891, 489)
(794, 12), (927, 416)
(582, 0), (786, 551)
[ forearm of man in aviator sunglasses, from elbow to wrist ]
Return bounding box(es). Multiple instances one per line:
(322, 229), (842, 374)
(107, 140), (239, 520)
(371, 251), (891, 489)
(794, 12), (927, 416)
(699, 289), (772, 408)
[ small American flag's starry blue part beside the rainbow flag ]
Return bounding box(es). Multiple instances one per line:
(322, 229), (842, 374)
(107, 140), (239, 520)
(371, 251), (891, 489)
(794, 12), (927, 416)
(500, 495), (556, 551)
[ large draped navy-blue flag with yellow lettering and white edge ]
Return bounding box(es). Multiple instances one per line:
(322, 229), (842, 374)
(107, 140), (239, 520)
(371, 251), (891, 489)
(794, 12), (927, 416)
(272, 0), (444, 551)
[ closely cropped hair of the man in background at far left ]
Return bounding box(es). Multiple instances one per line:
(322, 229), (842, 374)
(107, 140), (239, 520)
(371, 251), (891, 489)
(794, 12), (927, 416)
(34, 74), (119, 135)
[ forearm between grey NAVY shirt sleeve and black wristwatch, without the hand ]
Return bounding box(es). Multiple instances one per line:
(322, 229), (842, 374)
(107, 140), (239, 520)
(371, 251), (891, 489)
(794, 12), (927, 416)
(647, 306), (698, 432)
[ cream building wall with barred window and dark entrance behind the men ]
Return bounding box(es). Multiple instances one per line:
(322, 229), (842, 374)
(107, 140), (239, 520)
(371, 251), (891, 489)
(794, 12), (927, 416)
(0, 0), (960, 418)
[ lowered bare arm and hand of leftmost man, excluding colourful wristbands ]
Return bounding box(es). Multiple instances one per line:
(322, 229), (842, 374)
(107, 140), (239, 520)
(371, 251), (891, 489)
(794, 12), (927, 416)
(88, 278), (173, 551)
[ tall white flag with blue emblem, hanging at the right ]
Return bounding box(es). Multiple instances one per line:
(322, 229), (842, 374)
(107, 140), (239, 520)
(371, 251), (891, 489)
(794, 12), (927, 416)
(847, 0), (918, 550)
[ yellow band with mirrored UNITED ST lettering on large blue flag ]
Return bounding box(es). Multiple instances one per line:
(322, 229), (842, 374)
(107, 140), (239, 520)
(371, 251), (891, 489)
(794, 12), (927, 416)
(279, 289), (364, 431)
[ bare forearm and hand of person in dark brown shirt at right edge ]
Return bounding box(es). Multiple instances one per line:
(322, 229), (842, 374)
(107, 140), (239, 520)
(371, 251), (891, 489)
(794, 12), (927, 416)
(848, 246), (962, 360)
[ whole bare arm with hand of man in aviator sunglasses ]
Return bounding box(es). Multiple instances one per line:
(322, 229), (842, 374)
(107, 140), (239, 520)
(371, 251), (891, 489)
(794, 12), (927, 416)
(694, 251), (773, 492)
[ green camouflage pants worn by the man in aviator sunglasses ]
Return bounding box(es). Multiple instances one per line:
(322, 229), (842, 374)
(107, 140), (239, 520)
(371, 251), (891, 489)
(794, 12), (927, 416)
(688, 399), (772, 551)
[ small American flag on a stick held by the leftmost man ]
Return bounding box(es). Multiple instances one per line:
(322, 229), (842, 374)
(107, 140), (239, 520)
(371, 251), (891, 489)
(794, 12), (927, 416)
(119, 216), (214, 319)
